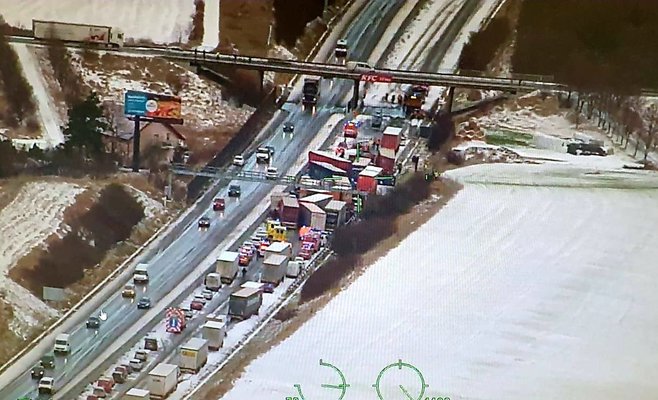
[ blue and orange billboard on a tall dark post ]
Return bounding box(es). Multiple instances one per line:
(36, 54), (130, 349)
(124, 90), (183, 124)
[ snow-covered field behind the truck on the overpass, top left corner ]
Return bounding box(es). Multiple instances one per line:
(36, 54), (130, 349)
(0, 0), (195, 43)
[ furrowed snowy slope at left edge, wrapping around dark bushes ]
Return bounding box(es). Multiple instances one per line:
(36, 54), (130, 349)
(0, 182), (85, 333)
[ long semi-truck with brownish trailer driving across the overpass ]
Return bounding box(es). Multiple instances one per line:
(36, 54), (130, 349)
(32, 19), (124, 47)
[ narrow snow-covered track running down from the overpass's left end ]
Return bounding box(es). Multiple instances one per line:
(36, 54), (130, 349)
(12, 43), (64, 147)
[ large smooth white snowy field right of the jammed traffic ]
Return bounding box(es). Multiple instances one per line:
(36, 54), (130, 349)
(219, 158), (658, 399)
